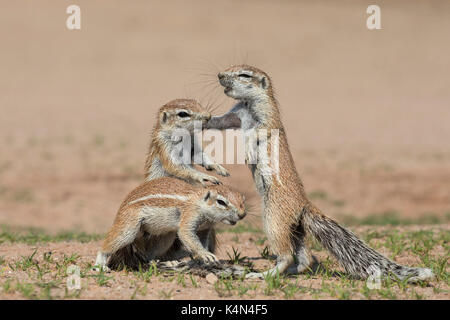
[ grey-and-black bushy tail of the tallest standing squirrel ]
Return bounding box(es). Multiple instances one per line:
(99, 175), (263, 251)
(301, 204), (434, 282)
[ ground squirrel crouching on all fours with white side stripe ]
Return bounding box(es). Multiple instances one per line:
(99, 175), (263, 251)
(95, 177), (246, 270)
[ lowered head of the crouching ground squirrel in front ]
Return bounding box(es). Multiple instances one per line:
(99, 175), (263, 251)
(199, 185), (247, 225)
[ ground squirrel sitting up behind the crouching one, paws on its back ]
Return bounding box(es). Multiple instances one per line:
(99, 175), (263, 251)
(145, 99), (229, 185)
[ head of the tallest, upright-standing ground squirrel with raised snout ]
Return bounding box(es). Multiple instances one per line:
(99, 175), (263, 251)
(218, 65), (273, 100)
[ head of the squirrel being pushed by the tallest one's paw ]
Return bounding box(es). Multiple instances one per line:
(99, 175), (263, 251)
(158, 99), (211, 133)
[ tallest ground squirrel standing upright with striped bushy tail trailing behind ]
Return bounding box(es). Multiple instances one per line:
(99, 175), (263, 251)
(208, 65), (433, 281)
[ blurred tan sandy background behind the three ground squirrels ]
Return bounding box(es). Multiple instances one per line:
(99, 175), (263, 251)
(0, 0), (450, 298)
